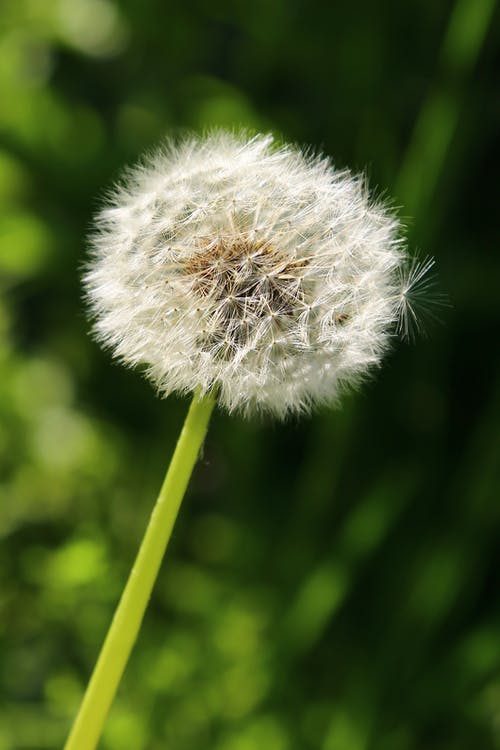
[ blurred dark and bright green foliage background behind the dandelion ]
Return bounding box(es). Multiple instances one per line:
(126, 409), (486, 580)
(0, 0), (500, 750)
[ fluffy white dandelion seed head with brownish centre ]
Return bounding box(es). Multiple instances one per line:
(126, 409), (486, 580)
(84, 132), (414, 416)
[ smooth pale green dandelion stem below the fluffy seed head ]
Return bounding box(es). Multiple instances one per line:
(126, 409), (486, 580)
(65, 394), (215, 750)
